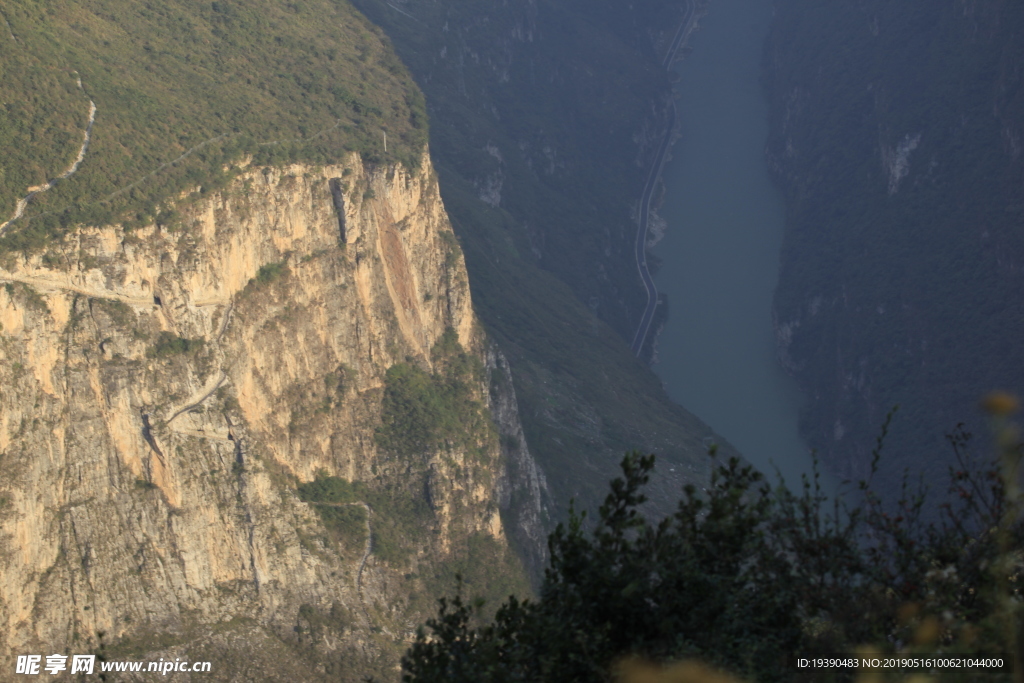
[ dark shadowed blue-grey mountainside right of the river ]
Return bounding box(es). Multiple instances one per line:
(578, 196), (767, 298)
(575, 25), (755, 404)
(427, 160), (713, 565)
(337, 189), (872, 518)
(765, 0), (1024, 487)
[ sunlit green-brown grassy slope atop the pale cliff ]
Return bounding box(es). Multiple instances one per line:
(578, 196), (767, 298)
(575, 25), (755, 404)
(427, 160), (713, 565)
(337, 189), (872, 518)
(0, 0), (427, 251)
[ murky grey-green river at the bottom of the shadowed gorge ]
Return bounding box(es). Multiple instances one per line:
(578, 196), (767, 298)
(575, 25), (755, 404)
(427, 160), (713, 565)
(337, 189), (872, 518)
(651, 0), (834, 489)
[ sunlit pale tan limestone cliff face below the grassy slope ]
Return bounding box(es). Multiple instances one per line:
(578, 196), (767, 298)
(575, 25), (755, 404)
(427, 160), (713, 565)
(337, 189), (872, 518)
(0, 155), (544, 680)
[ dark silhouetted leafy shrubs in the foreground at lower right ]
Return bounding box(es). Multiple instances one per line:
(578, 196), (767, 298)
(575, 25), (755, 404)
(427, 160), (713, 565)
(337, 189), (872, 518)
(402, 403), (1024, 683)
